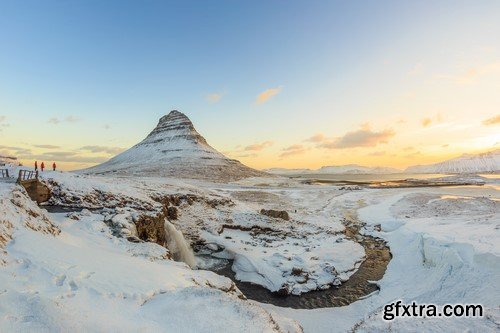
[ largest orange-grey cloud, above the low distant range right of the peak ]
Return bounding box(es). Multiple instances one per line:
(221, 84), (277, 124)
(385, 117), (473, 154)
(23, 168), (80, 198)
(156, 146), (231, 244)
(318, 124), (396, 149)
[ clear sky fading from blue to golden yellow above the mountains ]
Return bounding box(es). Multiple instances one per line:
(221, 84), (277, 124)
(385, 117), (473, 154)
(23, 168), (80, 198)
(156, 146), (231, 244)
(0, 0), (500, 170)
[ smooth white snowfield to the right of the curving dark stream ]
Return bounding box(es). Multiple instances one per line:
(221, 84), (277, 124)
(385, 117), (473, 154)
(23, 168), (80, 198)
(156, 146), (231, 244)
(266, 182), (500, 332)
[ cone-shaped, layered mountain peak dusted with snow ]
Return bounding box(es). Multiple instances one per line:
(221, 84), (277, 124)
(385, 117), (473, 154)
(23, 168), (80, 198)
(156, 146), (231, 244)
(81, 110), (267, 181)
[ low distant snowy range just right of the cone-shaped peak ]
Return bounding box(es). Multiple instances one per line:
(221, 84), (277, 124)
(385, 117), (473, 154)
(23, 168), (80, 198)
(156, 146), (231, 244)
(264, 164), (401, 175)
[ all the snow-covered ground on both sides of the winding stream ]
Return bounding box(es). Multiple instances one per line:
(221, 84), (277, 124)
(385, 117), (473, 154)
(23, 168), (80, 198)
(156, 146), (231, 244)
(0, 173), (500, 332)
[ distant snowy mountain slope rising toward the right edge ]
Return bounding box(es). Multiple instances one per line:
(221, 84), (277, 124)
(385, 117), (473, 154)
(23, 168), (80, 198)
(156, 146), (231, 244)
(405, 149), (500, 173)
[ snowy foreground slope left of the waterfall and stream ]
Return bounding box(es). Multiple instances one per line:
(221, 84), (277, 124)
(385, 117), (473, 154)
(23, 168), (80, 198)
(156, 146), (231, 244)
(0, 183), (300, 332)
